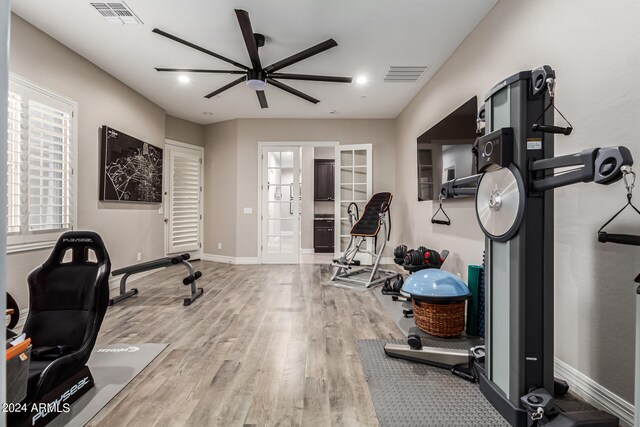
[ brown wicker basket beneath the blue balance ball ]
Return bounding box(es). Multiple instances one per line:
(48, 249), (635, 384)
(413, 299), (465, 337)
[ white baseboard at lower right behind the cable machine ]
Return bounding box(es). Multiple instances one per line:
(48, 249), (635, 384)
(555, 357), (635, 426)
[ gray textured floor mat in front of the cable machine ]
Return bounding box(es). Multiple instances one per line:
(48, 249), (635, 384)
(357, 340), (509, 427)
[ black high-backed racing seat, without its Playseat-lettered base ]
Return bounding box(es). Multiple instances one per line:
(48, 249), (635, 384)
(24, 231), (111, 402)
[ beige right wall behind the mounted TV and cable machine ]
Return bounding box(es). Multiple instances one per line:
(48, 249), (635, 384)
(394, 0), (640, 402)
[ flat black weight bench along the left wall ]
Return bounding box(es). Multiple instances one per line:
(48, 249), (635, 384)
(109, 253), (204, 306)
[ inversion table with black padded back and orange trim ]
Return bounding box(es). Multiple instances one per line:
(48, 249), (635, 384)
(331, 193), (398, 288)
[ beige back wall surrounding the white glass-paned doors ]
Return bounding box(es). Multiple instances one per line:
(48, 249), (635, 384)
(204, 119), (396, 258)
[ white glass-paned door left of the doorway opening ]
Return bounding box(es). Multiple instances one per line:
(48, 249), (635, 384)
(262, 147), (300, 264)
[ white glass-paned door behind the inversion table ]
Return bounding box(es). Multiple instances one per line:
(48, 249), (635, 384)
(334, 144), (373, 264)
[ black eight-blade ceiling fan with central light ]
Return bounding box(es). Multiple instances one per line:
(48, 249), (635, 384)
(153, 9), (351, 108)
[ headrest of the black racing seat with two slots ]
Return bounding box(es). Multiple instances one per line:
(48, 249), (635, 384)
(44, 231), (109, 267)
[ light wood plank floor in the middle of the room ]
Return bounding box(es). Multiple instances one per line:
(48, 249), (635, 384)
(88, 262), (403, 426)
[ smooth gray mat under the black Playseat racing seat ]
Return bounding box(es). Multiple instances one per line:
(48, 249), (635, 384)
(47, 344), (167, 427)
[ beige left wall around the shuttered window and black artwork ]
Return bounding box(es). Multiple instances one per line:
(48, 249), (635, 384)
(7, 15), (165, 307)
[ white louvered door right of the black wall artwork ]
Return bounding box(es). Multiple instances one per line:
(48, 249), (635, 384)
(165, 143), (203, 258)
